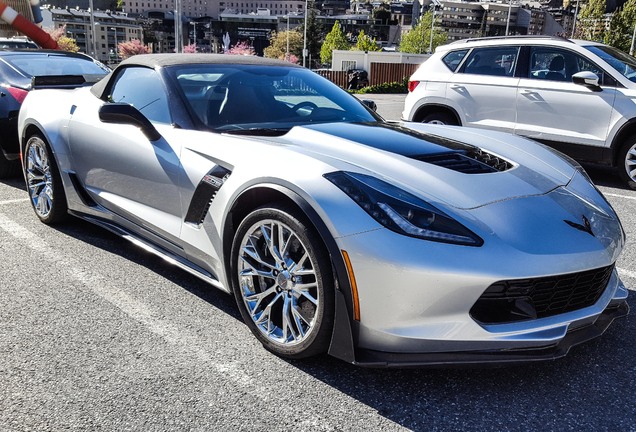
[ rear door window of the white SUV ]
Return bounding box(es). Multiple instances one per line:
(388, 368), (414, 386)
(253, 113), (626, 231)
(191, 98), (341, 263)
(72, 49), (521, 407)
(460, 46), (519, 77)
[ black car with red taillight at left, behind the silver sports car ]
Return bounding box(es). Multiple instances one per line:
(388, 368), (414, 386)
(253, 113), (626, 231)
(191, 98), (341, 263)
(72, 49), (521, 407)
(0, 50), (110, 178)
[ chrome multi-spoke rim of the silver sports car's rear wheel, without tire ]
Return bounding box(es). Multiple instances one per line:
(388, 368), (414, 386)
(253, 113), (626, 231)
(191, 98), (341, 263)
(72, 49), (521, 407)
(26, 136), (54, 219)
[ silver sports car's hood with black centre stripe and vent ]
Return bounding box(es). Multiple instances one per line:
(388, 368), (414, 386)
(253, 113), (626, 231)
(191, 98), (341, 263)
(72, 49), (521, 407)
(279, 123), (576, 209)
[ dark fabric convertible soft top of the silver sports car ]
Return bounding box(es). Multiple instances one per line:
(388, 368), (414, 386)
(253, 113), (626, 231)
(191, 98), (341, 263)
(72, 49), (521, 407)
(91, 54), (302, 98)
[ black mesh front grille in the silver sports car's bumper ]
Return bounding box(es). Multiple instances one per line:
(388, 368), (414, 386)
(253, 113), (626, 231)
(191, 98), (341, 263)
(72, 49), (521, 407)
(470, 265), (614, 324)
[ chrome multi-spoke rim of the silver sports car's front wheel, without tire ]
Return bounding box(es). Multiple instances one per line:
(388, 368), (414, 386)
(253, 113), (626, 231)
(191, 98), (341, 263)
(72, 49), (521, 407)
(237, 219), (321, 347)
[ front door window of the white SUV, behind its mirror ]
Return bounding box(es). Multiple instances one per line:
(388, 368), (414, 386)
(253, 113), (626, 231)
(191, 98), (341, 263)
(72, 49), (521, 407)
(528, 47), (604, 82)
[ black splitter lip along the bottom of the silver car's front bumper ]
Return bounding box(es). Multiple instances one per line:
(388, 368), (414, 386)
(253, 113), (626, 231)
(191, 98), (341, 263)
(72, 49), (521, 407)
(354, 301), (629, 368)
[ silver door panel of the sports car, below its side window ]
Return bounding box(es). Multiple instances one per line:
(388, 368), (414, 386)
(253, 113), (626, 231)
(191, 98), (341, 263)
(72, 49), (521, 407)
(69, 99), (182, 238)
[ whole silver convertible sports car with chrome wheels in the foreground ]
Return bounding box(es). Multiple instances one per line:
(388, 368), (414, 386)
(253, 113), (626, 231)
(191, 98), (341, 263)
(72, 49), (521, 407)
(19, 54), (628, 366)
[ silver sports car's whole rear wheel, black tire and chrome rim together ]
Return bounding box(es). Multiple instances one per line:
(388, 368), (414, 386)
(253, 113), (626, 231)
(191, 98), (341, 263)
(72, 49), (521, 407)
(24, 135), (68, 225)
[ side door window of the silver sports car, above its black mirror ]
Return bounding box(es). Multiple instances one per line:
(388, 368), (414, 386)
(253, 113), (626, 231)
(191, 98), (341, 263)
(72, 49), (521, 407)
(109, 67), (172, 123)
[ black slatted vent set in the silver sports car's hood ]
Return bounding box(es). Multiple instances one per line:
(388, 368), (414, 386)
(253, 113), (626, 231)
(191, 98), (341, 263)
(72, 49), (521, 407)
(413, 149), (512, 174)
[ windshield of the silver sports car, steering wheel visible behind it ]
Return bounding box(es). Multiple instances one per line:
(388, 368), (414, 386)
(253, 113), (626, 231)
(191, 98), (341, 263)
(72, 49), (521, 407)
(171, 64), (379, 134)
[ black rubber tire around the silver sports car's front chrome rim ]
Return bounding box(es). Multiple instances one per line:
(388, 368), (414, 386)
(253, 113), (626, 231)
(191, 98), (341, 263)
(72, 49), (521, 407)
(230, 205), (334, 358)
